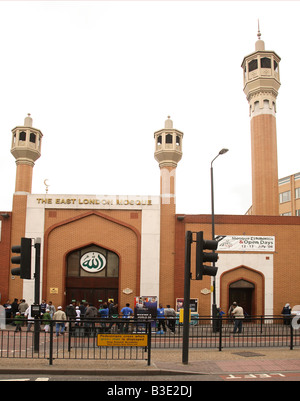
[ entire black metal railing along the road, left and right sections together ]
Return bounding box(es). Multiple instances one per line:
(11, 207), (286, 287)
(0, 316), (300, 365)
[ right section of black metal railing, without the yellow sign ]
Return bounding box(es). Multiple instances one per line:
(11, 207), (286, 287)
(152, 316), (300, 351)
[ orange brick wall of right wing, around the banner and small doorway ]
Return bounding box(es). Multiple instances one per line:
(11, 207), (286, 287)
(174, 215), (300, 314)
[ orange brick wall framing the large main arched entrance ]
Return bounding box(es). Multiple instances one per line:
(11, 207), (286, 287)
(43, 210), (141, 307)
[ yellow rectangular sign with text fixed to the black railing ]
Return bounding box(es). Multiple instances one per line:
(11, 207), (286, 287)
(97, 334), (148, 347)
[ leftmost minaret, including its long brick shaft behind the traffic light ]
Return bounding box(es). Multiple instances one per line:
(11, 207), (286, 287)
(9, 114), (43, 299)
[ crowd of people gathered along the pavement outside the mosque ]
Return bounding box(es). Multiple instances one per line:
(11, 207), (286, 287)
(3, 299), (300, 336)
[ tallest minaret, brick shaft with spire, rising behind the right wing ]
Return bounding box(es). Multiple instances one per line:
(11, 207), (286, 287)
(242, 27), (280, 216)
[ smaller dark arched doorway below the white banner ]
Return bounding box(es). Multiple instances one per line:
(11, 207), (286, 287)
(229, 279), (255, 316)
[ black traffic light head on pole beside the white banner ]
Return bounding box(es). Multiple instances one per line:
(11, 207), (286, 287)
(196, 231), (219, 280)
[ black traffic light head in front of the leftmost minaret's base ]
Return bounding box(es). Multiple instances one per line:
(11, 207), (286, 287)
(11, 238), (31, 279)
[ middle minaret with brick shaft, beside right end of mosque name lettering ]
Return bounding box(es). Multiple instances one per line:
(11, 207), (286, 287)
(154, 117), (183, 306)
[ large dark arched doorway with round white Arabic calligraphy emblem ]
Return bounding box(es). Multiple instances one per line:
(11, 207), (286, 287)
(66, 245), (119, 307)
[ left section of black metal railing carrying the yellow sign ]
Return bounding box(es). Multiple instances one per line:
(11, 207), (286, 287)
(0, 319), (151, 365)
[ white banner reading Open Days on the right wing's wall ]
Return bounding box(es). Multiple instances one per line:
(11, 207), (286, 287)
(216, 235), (275, 252)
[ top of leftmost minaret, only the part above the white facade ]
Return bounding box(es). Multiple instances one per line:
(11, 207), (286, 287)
(11, 114), (43, 193)
